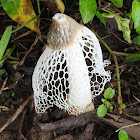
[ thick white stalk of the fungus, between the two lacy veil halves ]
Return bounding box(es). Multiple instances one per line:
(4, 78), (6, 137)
(66, 44), (94, 113)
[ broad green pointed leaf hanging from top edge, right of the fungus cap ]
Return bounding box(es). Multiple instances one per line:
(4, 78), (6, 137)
(79, 0), (97, 24)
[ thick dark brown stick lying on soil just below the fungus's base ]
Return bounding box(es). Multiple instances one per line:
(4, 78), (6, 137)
(38, 112), (97, 133)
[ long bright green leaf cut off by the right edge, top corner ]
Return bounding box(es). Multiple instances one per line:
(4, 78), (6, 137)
(132, 0), (140, 29)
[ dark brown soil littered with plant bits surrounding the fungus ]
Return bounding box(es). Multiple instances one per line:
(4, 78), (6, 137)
(0, 1), (140, 140)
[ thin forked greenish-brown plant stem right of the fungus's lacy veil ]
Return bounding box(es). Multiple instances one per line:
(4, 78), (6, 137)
(91, 29), (122, 114)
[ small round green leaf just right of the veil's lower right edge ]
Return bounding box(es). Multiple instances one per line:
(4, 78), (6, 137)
(104, 87), (115, 99)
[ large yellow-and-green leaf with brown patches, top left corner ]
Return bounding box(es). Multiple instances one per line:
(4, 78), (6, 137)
(1, 0), (40, 33)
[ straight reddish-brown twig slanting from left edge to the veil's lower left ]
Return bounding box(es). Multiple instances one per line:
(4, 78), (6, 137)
(0, 94), (33, 133)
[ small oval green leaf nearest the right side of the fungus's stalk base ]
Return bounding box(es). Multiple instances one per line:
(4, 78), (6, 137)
(97, 104), (107, 117)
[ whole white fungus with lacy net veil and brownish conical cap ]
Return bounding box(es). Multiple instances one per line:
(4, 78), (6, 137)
(32, 13), (111, 115)
